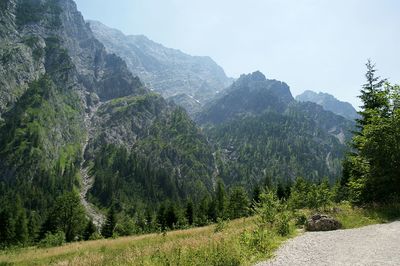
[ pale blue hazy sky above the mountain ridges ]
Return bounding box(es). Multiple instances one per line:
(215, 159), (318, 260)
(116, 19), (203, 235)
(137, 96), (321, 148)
(76, 0), (400, 106)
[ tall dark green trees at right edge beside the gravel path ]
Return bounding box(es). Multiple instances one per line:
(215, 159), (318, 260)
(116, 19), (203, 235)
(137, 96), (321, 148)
(343, 61), (400, 203)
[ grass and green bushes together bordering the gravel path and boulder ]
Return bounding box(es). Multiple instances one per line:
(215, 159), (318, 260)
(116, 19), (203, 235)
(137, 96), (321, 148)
(0, 175), (400, 265)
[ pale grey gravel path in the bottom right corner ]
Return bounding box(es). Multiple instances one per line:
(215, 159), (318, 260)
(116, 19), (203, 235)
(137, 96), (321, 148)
(258, 221), (400, 266)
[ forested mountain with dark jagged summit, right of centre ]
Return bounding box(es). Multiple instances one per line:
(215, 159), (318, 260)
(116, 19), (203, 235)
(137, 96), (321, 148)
(197, 71), (354, 187)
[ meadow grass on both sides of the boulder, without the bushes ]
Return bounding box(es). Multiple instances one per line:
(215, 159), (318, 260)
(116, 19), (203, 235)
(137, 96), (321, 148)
(0, 203), (400, 266)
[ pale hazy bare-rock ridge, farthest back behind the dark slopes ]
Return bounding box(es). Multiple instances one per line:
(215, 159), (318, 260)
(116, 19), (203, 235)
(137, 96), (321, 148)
(88, 21), (232, 113)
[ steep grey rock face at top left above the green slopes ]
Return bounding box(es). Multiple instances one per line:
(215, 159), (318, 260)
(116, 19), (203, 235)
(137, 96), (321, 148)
(0, 0), (148, 117)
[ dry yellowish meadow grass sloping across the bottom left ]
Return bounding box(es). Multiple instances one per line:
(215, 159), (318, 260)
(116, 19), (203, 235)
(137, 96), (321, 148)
(0, 218), (268, 265)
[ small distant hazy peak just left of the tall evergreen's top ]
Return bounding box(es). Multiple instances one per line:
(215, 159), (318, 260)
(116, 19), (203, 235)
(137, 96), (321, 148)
(296, 90), (359, 120)
